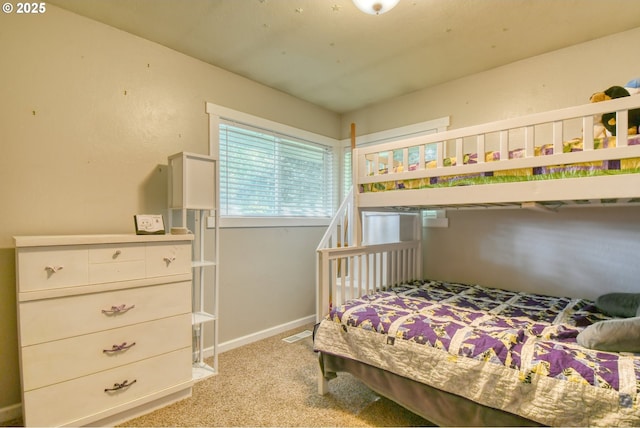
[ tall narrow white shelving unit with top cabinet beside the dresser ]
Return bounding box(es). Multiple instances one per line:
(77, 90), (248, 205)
(169, 152), (219, 381)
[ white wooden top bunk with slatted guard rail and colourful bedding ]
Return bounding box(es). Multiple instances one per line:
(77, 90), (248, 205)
(353, 95), (640, 210)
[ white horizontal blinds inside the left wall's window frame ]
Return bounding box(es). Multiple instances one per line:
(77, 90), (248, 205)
(219, 120), (334, 217)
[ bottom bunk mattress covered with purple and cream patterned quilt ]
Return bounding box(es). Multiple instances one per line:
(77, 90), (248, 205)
(314, 280), (640, 426)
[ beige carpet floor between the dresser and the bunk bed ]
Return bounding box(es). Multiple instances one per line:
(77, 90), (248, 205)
(122, 326), (431, 427)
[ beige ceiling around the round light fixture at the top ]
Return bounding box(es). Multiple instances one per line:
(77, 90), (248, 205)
(49, 0), (640, 113)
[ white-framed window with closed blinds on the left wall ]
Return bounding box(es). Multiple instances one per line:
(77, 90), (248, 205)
(207, 103), (340, 227)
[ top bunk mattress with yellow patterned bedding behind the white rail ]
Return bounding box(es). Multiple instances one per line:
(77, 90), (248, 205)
(360, 135), (640, 192)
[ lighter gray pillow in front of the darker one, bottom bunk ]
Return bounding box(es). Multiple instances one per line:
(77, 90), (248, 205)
(576, 316), (640, 352)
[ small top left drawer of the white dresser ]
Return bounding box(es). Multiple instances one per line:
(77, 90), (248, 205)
(17, 246), (89, 292)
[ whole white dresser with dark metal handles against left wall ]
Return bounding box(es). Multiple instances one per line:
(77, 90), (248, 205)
(15, 235), (193, 426)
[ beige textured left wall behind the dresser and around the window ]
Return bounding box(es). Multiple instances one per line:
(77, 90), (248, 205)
(0, 5), (339, 410)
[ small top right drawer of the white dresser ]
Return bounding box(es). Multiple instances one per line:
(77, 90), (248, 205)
(147, 243), (191, 278)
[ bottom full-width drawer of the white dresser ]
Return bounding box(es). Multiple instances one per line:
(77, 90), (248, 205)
(23, 347), (191, 426)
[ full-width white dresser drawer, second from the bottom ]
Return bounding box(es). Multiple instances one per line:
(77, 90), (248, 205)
(22, 314), (191, 391)
